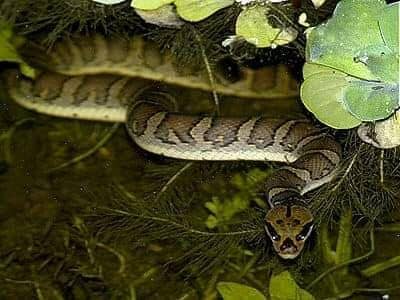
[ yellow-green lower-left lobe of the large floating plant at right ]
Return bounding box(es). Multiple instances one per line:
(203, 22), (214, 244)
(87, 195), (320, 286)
(300, 63), (361, 129)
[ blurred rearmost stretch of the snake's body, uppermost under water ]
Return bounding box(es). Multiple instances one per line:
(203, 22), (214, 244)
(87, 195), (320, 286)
(22, 35), (298, 99)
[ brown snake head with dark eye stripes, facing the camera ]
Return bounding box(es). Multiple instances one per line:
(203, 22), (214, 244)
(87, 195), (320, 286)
(265, 205), (314, 259)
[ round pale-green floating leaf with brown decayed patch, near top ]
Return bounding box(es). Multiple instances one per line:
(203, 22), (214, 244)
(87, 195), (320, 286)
(236, 5), (297, 48)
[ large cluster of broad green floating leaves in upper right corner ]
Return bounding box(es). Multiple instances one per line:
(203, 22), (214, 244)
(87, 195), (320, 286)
(301, 0), (400, 129)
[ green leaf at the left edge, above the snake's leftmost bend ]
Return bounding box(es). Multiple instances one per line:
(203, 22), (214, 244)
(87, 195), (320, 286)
(0, 22), (35, 77)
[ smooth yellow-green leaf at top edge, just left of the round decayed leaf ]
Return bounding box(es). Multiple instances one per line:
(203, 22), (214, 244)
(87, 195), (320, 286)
(173, 0), (235, 22)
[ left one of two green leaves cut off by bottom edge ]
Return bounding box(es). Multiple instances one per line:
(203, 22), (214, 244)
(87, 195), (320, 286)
(217, 282), (266, 300)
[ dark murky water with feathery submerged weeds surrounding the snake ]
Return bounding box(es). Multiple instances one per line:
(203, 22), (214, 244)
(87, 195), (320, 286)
(0, 0), (400, 300)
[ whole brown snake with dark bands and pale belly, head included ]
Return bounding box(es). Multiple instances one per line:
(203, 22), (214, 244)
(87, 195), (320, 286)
(3, 36), (341, 259)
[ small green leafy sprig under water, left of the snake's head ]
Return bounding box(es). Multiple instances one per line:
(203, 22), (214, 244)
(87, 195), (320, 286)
(205, 169), (269, 229)
